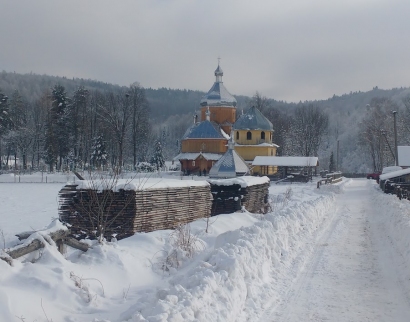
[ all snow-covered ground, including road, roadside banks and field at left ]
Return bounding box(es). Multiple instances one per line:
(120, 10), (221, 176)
(0, 179), (410, 322)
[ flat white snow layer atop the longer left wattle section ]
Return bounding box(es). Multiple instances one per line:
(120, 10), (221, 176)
(76, 178), (208, 191)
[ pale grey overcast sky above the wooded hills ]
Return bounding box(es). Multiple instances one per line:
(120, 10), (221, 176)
(0, 0), (410, 102)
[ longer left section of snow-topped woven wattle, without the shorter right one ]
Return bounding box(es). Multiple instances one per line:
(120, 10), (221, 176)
(59, 179), (212, 239)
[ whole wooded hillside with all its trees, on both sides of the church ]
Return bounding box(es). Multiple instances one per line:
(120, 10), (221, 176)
(0, 71), (410, 173)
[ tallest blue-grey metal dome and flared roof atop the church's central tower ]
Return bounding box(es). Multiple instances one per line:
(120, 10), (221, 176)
(200, 64), (236, 107)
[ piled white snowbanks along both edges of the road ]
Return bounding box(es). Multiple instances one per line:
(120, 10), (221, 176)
(4, 180), (410, 322)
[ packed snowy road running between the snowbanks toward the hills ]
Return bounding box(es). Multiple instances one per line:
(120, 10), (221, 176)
(269, 180), (410, 321)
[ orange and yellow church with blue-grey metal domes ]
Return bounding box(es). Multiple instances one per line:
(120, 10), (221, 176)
(174, 64), (278, 175)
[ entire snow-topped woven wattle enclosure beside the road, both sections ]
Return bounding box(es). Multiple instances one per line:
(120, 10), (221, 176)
(59, 177), (270, 239)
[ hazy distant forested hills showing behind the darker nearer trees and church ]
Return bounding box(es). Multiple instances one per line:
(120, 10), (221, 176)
(0, 71), (410, 172)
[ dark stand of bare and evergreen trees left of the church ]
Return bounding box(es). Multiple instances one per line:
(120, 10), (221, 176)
(0, 84), (150, 171)
